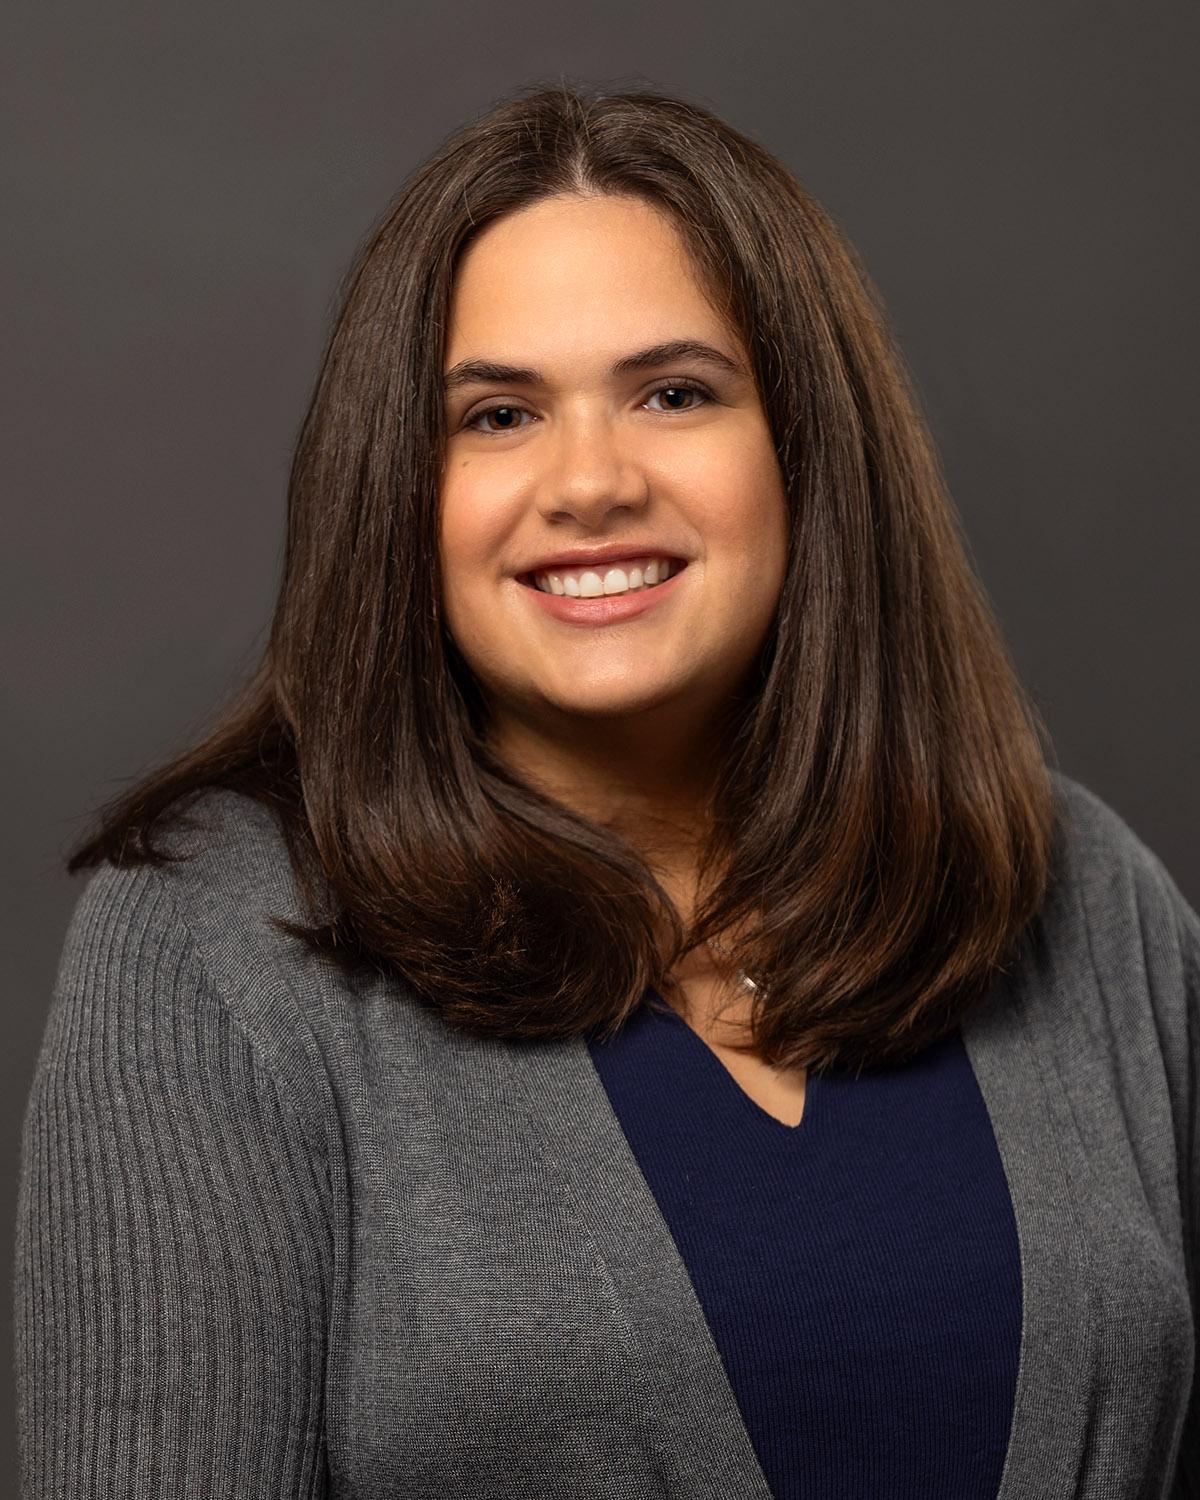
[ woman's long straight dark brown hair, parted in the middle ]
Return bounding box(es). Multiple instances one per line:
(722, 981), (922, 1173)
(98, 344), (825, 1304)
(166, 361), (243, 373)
(68, 81), (1056, 1071)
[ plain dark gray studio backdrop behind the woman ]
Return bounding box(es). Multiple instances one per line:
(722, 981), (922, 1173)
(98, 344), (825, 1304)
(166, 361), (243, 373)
(0, 0), (1200, 1490)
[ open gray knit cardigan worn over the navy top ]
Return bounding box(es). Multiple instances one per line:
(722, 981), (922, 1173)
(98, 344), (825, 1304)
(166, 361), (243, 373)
(15, 773), (1200, 1500)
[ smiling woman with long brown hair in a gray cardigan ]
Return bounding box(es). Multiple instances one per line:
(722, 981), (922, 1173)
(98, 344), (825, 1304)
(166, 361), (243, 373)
(17, 87), (1200, 1500)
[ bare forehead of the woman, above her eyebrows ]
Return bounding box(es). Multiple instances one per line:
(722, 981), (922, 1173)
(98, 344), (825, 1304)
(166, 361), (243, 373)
(446, 195), (731, 366)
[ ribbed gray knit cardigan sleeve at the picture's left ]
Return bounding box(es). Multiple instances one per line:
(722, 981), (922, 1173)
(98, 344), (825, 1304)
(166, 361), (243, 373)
(15, 867), (332, 1500)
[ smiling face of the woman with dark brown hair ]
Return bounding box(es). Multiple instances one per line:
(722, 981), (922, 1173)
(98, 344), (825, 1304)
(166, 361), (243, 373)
(440, 195), (788, 750)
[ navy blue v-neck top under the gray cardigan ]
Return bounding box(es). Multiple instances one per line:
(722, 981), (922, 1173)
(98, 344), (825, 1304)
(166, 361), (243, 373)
(588, 1005), (1022, 1500)
